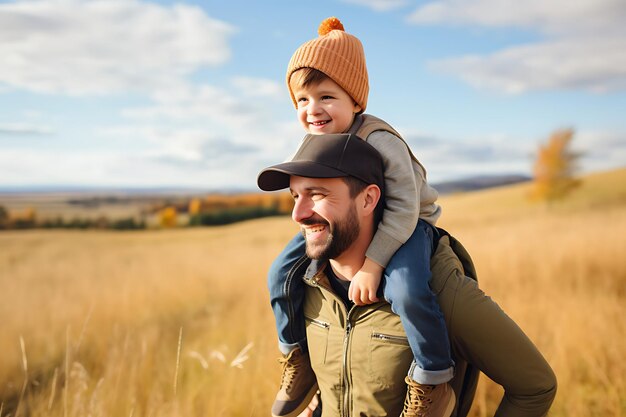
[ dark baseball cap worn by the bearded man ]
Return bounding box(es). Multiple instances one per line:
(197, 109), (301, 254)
(257, 133), (384, 191)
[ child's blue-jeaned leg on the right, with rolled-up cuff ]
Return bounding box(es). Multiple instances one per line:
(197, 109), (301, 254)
(381, 219), (454, 385)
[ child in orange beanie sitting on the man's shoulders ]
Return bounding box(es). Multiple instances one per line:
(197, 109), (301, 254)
(268, 18), (455, 417)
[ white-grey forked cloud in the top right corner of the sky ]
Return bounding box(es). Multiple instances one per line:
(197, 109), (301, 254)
(408, 0), (626, 93)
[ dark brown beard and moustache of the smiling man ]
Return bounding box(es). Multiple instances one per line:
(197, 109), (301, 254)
(302, 202), (361, 259)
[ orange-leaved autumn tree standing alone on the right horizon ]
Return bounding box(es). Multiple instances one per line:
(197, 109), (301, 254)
(531, 129), (581, 203)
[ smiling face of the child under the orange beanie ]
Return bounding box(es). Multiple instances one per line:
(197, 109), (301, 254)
(293, 78), (361, 135)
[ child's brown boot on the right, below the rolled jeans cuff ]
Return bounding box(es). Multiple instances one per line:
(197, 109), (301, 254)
(400, 376), (456, 417)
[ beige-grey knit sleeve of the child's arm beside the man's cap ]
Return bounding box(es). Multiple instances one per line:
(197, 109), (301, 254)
(366, 131), (425, 267)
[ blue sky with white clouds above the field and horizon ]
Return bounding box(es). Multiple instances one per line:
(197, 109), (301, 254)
(0, 0), (626, 190)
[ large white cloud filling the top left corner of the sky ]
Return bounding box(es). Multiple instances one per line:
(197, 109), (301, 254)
(0, 0), (235, 95)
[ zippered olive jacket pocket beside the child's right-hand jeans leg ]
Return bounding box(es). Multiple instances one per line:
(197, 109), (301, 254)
(369, 329), (413, 389)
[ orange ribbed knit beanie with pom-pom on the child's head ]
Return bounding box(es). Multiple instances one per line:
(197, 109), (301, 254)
(287, 17), (369, 111)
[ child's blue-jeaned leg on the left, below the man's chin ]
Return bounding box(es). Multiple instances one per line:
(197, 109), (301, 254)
(267, 233), (307, 355)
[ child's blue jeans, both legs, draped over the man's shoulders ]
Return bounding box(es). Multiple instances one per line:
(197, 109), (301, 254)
(268, 219), (454, 385)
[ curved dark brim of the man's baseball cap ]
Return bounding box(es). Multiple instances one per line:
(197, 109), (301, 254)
(257, 161), (348, 191)
